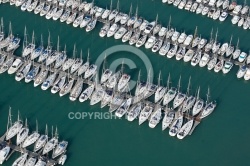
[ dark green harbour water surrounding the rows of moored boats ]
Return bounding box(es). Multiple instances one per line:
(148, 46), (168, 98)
(0, 0), (250, 166)
